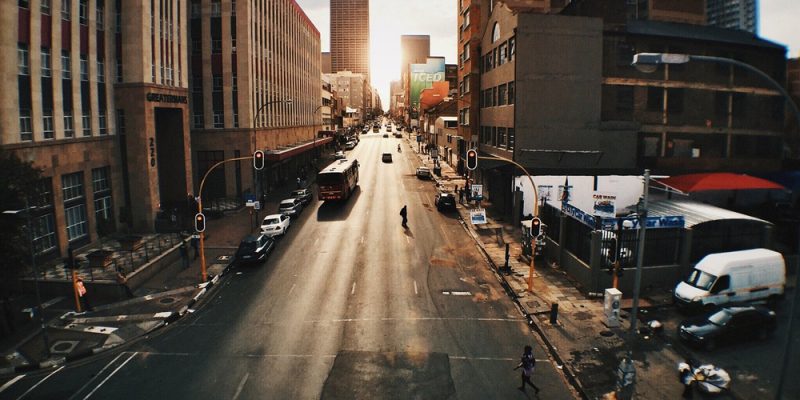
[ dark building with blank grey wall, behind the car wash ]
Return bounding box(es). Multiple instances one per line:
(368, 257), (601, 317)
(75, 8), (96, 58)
(468, 0), (786, 220)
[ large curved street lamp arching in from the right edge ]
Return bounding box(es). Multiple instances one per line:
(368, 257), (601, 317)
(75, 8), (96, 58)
(631, 53), (800, 399)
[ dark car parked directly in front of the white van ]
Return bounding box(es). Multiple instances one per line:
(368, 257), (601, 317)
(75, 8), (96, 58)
(678, 306), (775, 350)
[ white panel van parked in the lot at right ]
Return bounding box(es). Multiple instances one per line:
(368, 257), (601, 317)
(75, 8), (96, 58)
(675, 249), (786, 307)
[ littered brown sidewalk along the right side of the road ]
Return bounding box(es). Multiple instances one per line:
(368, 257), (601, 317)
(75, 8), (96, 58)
(409, 138), (724, 399)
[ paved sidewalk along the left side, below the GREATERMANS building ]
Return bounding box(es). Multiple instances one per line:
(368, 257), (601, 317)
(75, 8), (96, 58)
(0, 157), (330, 375)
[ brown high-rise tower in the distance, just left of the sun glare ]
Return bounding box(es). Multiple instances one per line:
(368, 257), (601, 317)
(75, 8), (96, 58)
(331, 0), (370, 82)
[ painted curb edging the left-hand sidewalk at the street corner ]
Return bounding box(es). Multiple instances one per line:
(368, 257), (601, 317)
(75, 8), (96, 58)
(0, 263), (233, 376)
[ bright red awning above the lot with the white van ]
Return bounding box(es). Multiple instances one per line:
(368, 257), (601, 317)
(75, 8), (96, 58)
(658, 172), (785, 193)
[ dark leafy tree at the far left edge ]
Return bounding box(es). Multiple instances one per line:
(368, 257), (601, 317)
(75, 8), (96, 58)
(0, 148), (42, 298)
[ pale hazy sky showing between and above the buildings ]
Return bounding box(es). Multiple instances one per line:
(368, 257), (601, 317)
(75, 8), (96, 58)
(296, 0), (800, 109)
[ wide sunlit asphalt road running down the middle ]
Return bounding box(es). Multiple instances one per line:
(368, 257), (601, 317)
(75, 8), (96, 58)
(0, 123), (575, 399)
